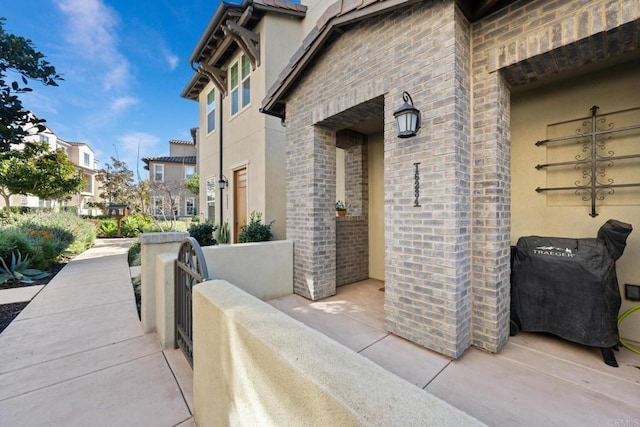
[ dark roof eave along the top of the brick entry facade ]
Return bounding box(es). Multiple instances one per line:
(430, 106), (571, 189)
(260, 0), (516, 119)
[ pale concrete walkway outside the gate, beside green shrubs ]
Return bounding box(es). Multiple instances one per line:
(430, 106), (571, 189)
(0, 239), (195, 427)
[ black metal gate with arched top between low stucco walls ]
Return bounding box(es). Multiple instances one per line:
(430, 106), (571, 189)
(175, 237), (209, 366)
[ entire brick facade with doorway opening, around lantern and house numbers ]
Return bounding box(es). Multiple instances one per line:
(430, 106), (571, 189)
(286, 0), (640, 357)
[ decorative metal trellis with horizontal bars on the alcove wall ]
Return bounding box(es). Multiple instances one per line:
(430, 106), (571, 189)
(536, 105), (640, 218)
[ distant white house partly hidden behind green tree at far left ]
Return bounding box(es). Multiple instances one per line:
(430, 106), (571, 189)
(0, 127), (102, 216)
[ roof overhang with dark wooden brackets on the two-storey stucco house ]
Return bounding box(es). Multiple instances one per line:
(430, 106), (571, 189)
(180, 0), (307, 101)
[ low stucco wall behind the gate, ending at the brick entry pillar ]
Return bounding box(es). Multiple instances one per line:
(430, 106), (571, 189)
(202, 240), (293, 300)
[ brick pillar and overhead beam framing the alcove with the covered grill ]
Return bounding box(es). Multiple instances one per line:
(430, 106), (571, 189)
(471, 0), (640, 351)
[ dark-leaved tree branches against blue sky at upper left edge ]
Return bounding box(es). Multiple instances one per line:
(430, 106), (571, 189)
(0, 18), (62, 152)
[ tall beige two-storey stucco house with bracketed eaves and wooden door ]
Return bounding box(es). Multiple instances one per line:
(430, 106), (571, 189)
(181, 0), (306, 242)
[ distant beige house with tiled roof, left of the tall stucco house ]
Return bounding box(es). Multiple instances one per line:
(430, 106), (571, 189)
(142, 139), (198, 218)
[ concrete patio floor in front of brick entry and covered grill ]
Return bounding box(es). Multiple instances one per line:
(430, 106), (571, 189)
(269, 280), (640, 426)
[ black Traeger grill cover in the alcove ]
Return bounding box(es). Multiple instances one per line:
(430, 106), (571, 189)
(511, 220), (632, 347)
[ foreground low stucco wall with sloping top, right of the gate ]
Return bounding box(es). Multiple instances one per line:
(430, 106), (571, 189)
(193, 280), (481, 427)
